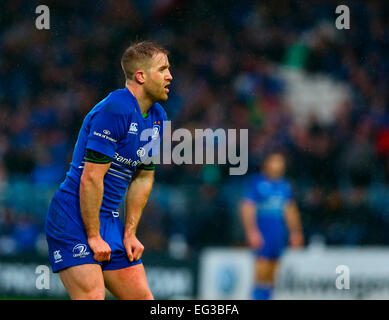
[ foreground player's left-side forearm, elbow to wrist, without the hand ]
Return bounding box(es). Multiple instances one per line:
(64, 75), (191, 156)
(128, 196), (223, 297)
(80, 176), (104, 238)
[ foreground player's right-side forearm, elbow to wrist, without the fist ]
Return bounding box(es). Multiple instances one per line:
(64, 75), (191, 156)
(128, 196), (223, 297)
(124, 176), (154, 236)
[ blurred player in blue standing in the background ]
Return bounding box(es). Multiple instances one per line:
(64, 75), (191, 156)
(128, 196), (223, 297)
(240, 153), (304, 300)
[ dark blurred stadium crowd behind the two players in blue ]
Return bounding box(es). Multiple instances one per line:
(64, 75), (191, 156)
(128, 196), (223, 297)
(0, 0), (389, 298)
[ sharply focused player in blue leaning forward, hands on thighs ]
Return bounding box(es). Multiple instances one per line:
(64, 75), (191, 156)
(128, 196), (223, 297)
(46, 42), (172, 299)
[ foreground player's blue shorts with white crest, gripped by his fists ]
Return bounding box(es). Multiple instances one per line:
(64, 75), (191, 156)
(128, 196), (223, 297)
(45, 190), (142, 272)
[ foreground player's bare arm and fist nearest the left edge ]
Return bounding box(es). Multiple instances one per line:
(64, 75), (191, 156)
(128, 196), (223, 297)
(80, 162), (111, 262)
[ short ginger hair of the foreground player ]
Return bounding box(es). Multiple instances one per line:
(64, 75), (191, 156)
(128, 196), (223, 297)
(120, 41), (169, 81)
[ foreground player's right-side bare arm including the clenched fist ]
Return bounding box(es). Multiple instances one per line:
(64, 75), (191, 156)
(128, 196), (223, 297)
(123, 169), (154, 261)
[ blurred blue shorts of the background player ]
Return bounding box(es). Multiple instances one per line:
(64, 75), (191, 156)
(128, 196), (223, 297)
(254, 217), (288, 260)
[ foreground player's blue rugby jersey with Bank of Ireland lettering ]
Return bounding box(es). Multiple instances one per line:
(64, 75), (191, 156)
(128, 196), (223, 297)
(60, 88), (167, 213)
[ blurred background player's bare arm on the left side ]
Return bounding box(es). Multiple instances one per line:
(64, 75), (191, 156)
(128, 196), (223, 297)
(240, 199), (263, 249)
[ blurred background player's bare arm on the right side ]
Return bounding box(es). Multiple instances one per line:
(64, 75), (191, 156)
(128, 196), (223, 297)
(285, 201), (304, 247)
